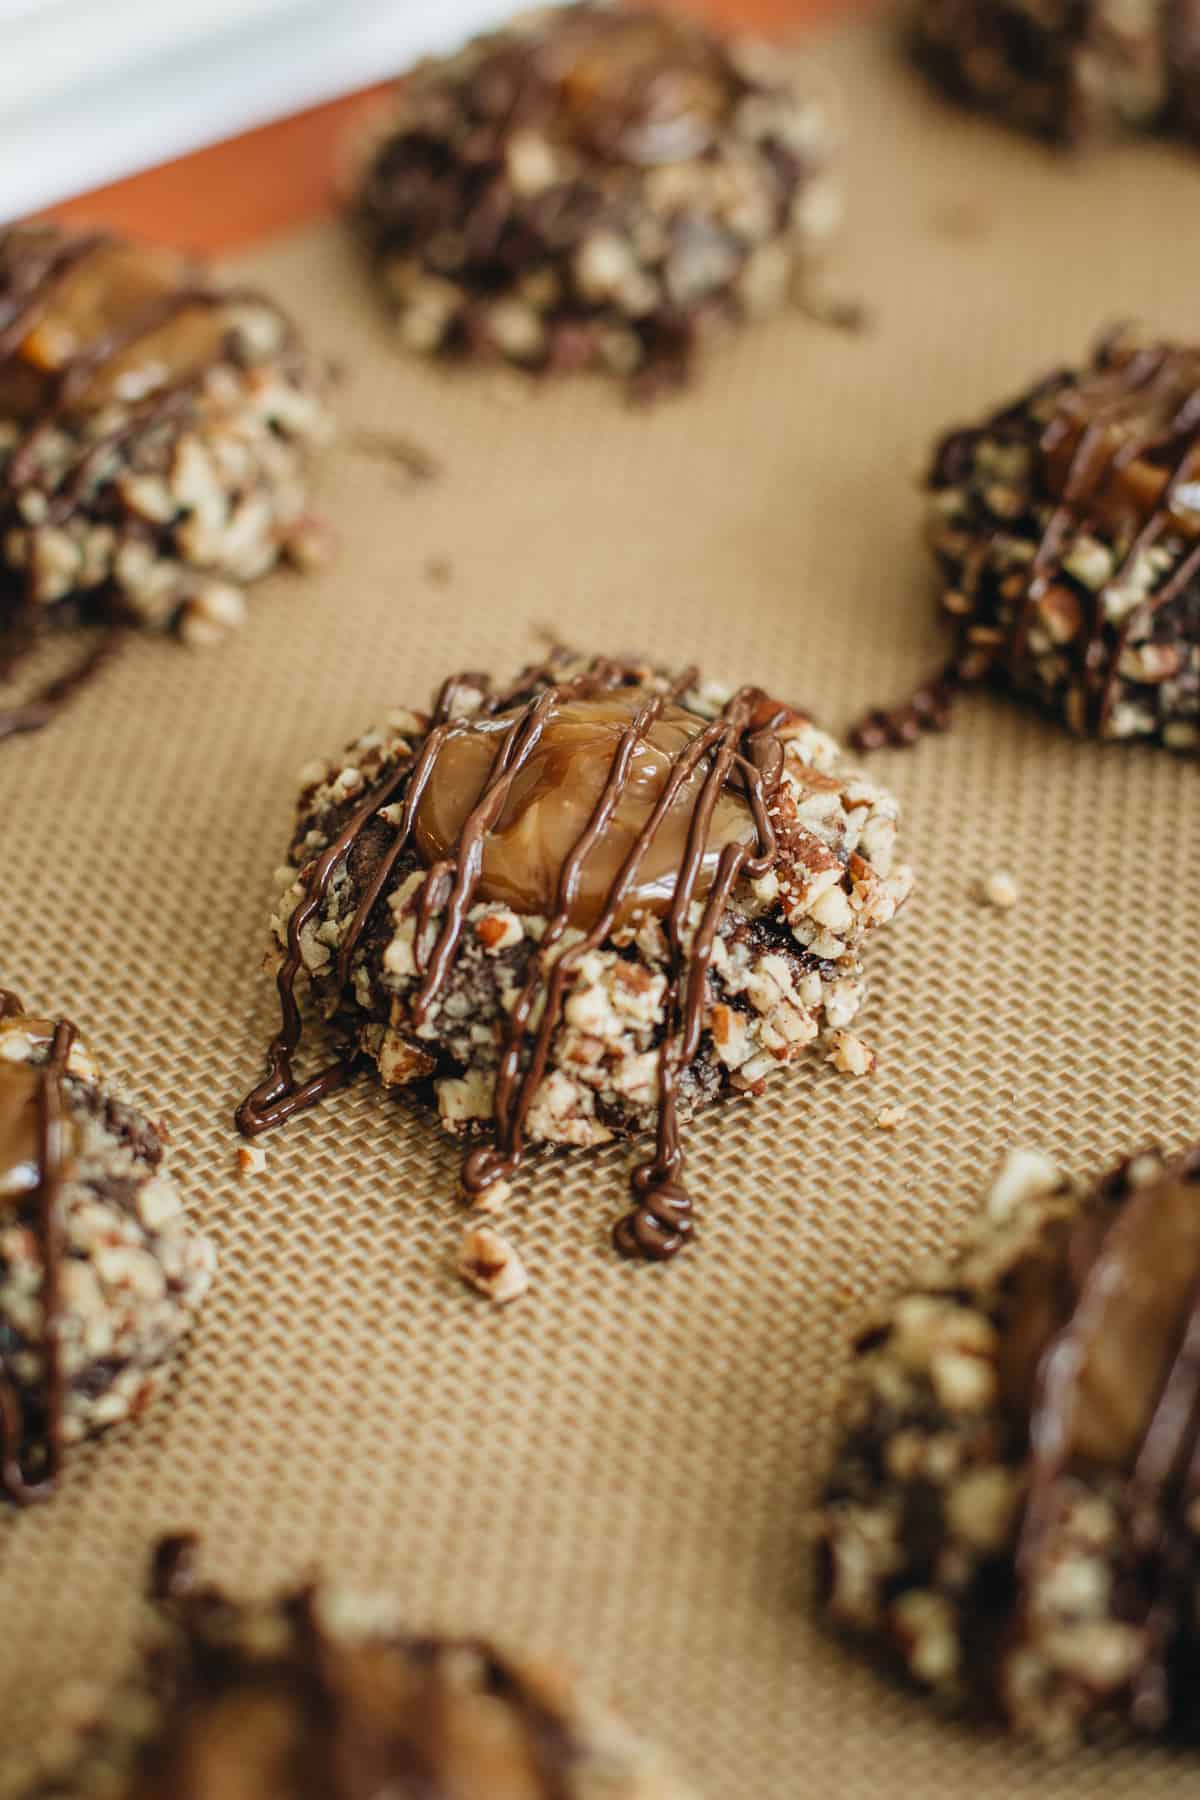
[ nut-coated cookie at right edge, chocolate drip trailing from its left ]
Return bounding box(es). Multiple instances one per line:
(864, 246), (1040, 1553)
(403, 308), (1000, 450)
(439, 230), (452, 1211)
(851, 329), (1200, 751)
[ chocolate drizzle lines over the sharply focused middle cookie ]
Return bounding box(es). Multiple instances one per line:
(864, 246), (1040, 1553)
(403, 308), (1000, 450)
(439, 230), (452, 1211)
(237, 659), (790, 1260)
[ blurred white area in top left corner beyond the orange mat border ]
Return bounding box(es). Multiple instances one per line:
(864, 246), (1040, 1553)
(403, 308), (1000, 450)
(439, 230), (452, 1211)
(0, 0), (511, 220)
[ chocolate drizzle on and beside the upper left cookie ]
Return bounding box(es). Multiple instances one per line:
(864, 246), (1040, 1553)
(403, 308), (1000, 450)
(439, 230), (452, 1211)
(0, 227), (293, 740)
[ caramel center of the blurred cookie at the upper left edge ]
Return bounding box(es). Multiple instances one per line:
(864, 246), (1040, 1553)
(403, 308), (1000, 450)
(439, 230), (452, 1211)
(0, 243), (227, 419)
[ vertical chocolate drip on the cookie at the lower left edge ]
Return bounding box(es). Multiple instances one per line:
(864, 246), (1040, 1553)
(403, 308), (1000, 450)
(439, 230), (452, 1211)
(0, 988), (76, 1507)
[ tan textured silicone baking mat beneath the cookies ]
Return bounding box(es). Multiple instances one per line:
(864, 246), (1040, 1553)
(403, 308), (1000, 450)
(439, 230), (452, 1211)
(0, 17), (1200, 1800)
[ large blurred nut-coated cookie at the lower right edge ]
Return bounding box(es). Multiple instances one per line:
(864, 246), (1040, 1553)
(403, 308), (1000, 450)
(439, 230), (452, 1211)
(819, 1152), (1200, 1746)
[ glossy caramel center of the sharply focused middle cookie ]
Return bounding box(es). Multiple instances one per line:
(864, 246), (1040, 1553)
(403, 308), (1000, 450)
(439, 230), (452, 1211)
(414, 691), (756, 929)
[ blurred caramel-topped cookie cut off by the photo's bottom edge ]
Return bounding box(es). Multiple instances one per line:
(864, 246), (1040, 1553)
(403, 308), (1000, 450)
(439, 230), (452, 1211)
(27, 1539), (694, 1800)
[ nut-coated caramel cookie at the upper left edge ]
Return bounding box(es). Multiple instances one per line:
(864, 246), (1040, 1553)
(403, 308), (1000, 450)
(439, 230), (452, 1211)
(0, 225), (329, 734)
